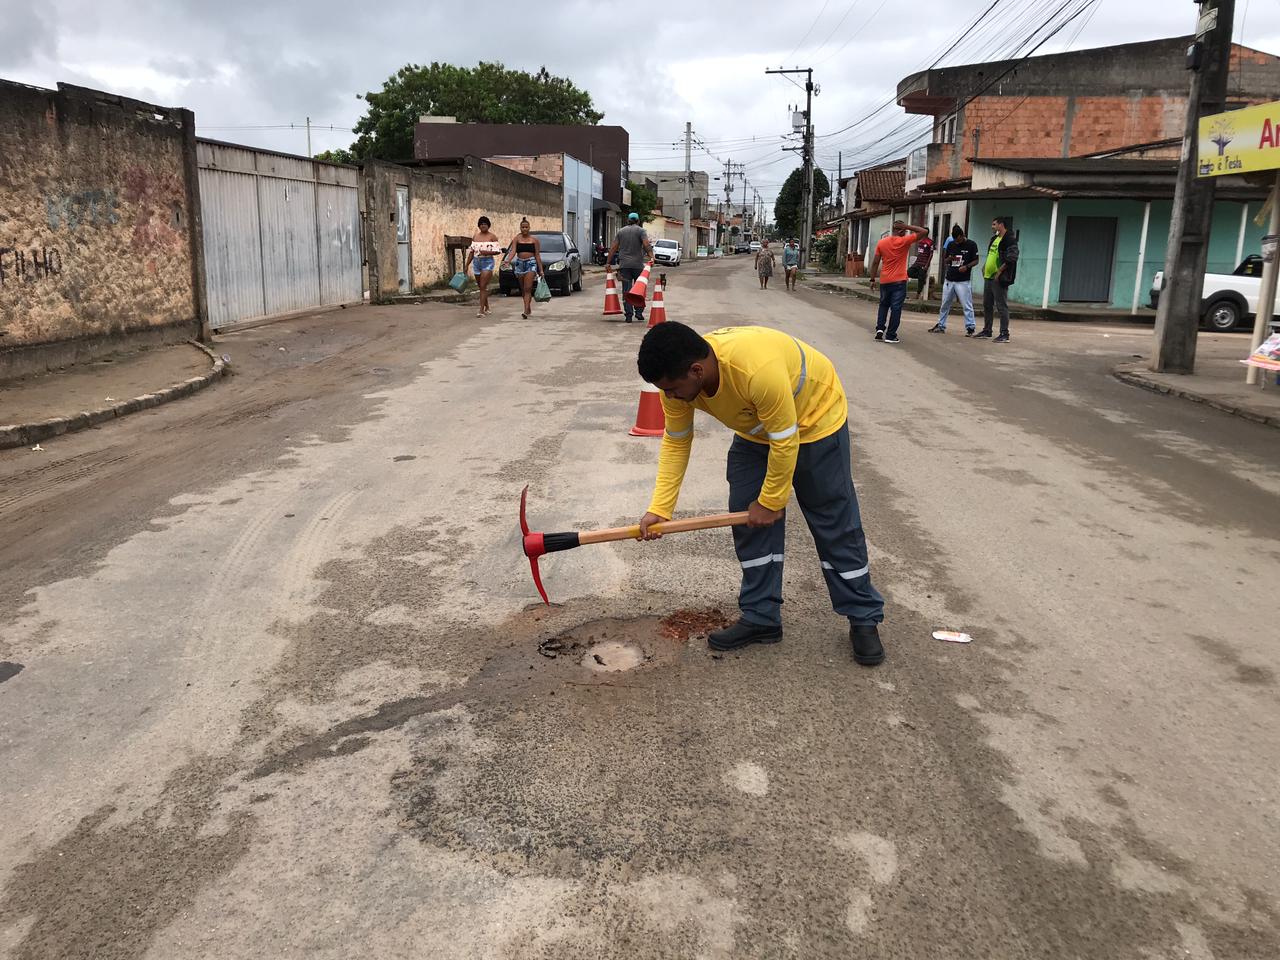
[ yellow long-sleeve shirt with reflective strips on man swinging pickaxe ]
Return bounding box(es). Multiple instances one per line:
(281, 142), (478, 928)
(649, 326), (849, 520)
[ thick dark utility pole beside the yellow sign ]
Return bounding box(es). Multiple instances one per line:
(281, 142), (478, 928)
(1151, 0), (1235, 374)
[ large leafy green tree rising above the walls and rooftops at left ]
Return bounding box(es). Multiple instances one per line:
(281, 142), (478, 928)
(351, 61), (604, 160)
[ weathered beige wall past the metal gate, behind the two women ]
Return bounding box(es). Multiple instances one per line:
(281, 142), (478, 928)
(364, 156), (564, 301)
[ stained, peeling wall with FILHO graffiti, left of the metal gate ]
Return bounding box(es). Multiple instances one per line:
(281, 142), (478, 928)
(0, 81), (204, 375)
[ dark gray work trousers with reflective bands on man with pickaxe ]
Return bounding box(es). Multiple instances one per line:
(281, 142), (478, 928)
(727, 426), (884, 626)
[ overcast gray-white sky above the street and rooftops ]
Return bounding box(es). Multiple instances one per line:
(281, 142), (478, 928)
(0, 0), (1280, 205)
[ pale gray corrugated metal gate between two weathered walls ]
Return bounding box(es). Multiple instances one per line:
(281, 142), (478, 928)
(196, 140), (364, 330)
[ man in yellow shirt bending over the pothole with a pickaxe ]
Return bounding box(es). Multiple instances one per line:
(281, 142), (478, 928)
(639, 320), (884, 667)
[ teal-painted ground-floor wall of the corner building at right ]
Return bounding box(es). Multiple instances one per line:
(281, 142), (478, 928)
(969, 200), (1266, 310)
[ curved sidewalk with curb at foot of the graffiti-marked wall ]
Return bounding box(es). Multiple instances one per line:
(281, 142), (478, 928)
(0, 342), (227, 449)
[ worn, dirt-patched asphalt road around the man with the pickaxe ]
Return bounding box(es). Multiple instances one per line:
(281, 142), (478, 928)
(0, 257), (1280, 960)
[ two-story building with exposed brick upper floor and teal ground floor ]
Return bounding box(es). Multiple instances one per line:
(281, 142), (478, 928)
(897, 37), (1280, 310)
